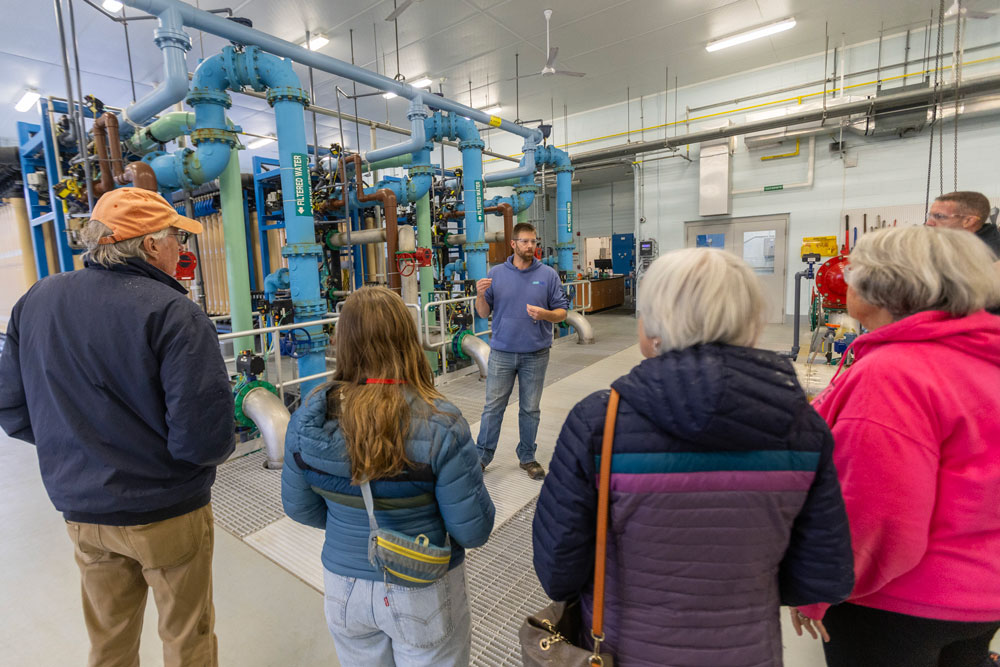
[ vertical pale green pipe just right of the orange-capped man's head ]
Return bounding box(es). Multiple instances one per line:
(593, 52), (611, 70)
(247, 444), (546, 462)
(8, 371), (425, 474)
(219, 148), (253, 354)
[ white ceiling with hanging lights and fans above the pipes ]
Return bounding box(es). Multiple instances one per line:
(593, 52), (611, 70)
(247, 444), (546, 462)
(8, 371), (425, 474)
(0, 0), (984, 153)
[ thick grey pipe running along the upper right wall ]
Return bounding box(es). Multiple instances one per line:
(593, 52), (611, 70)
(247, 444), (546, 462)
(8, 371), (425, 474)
(568, 74), (1000, 165)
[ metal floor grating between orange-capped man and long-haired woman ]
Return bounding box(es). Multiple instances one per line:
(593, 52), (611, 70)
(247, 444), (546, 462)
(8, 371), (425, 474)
(212, 450), (285, 540)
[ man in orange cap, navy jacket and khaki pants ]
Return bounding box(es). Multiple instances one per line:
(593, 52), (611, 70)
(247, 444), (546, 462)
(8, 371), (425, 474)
(0, 188), (234, 667)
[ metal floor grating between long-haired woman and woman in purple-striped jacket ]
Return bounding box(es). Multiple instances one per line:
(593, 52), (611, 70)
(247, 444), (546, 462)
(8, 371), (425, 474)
(465, 498), (550, 667)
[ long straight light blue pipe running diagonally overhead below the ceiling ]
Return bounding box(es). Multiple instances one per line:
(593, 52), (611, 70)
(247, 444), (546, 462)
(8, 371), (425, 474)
(123, 0), (542, 144)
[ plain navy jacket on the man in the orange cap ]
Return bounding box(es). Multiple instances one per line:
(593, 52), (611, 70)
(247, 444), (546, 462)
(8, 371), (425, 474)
(0, 259), (234, 525)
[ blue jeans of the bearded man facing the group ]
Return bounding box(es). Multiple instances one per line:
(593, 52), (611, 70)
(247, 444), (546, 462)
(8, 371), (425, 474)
(476, 348), (549, 465)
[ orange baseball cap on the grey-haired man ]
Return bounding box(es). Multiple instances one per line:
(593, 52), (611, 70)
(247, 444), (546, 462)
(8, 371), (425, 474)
(90, 188), (204, 245)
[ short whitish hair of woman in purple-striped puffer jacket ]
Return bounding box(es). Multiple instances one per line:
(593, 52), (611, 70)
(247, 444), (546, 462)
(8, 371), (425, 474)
(639, 248), (764, 353)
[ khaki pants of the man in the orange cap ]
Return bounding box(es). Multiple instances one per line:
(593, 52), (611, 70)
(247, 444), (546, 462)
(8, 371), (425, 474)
(66, 505), (219, 667)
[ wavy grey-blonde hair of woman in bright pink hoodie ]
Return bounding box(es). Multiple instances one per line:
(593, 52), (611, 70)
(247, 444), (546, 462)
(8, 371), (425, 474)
(844, 226), (1000, 320)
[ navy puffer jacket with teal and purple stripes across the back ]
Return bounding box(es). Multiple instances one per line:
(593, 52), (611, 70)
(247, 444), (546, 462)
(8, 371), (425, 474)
(534, 345), (854, 667)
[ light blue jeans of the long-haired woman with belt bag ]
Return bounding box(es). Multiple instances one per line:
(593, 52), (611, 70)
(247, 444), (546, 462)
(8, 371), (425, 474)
(323, 563), (472, 667)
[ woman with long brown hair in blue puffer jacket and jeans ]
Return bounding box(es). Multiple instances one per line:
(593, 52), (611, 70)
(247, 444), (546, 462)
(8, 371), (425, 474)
(281, 287), (494, 667)
